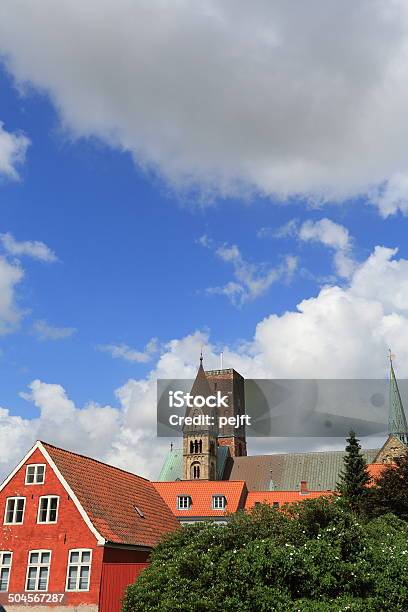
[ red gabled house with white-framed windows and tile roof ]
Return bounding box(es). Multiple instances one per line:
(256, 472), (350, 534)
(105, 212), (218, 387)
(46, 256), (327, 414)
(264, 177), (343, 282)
(0, 442), (178, 612)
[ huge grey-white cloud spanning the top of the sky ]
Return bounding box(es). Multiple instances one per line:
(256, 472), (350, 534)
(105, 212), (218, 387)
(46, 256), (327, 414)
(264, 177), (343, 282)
(0, 0), (408, 208)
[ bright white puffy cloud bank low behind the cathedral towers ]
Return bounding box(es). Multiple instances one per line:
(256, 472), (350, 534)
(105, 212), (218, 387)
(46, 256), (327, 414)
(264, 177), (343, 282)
(0, 247), (408, 478)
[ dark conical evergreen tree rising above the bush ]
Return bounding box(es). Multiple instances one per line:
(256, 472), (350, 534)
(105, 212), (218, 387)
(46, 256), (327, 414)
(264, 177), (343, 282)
(337, 431), (371, 511)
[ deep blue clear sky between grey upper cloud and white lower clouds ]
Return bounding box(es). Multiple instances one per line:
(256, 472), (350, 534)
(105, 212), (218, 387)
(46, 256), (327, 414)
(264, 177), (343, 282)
(0, 62), (407, 414)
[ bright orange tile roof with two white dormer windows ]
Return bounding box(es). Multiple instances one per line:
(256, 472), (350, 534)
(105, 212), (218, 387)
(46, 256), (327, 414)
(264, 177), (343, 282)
(152, 480), (247, 518)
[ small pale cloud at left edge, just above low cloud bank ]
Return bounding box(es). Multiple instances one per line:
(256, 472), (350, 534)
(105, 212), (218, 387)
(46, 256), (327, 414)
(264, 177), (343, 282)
(0, 256), (24, 335)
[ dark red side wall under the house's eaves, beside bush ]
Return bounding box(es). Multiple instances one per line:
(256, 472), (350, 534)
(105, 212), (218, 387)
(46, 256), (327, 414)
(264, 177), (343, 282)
(99, 563), (149, 612)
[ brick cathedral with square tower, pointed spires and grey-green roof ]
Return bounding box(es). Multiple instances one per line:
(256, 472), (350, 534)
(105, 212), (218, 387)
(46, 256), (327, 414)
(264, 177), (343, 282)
(159, 356), (408, 491)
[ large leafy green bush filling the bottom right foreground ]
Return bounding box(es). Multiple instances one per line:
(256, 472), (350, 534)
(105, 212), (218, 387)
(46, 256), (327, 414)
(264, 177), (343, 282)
(123, 497), (408, 612)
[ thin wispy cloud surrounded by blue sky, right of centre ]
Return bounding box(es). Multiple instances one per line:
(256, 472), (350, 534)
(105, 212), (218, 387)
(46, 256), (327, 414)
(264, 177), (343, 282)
(203, 237), (297, 306)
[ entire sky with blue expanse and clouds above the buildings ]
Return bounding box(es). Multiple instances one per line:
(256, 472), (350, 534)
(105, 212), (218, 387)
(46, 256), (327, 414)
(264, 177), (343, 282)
(0, 0), (408, 478)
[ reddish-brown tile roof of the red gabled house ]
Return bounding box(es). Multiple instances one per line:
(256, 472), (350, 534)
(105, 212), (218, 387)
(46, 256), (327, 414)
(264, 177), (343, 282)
(42, 442), (178, 547)
